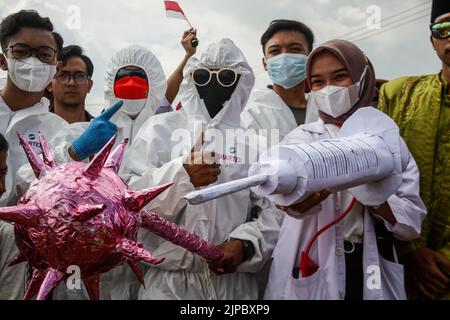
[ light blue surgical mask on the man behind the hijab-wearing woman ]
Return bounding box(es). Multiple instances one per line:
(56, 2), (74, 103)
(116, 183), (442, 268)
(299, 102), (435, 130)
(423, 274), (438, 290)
(267, 53), (308, 89)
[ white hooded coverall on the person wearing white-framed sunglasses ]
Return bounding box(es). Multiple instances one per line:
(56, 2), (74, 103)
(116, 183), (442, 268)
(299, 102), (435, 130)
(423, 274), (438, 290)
(118, 39), (282, 299)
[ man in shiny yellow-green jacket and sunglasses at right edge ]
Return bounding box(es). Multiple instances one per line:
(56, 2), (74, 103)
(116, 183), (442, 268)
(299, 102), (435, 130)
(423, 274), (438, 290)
(379, 0), (450, 299)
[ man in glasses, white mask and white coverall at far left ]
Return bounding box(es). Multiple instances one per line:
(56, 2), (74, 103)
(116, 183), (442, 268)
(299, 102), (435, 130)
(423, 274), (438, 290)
(0, 11), (67, 300)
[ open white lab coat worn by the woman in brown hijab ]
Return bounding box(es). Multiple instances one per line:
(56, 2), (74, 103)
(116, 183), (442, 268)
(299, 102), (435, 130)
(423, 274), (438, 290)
(265, 120), (426, 300)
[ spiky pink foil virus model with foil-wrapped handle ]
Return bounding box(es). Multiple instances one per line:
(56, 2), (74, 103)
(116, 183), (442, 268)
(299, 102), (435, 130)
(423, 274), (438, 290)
(0, 133), (223, 300)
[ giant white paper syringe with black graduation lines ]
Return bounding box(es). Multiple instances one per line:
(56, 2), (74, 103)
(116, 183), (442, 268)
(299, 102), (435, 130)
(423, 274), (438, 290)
(185, 107), (408, 206)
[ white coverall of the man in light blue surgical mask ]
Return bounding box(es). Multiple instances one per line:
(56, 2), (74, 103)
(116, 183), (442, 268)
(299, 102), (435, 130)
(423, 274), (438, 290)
(241, 88), (298, 145)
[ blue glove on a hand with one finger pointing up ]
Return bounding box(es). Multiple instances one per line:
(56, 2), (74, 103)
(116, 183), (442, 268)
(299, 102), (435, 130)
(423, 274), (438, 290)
(72, 101), (123, 160)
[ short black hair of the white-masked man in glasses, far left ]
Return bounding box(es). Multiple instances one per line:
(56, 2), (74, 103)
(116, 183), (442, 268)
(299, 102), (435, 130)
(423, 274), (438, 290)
(0, 10), (64, 52)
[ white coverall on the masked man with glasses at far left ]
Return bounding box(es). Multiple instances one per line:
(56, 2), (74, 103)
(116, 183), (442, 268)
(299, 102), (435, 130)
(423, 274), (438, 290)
(0, 97), (67, 300)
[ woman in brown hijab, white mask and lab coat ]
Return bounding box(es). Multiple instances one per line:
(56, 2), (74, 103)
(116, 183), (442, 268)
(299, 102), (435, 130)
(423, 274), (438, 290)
(265, 40), (426, 300)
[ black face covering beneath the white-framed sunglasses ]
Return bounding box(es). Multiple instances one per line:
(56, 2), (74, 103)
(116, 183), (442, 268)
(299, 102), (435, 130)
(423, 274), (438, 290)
(196, 74), (240, 119)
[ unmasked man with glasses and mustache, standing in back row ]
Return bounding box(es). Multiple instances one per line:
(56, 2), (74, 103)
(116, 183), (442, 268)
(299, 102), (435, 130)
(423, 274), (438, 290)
(47, 46), (94, 123)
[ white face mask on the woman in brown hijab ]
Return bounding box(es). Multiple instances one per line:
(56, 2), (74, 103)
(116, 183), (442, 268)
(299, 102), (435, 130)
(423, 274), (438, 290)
(312, 67), (367, 118)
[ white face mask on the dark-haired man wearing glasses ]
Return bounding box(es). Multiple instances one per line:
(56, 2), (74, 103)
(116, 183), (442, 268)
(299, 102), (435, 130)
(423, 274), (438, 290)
(6, 57), (56, 92)
